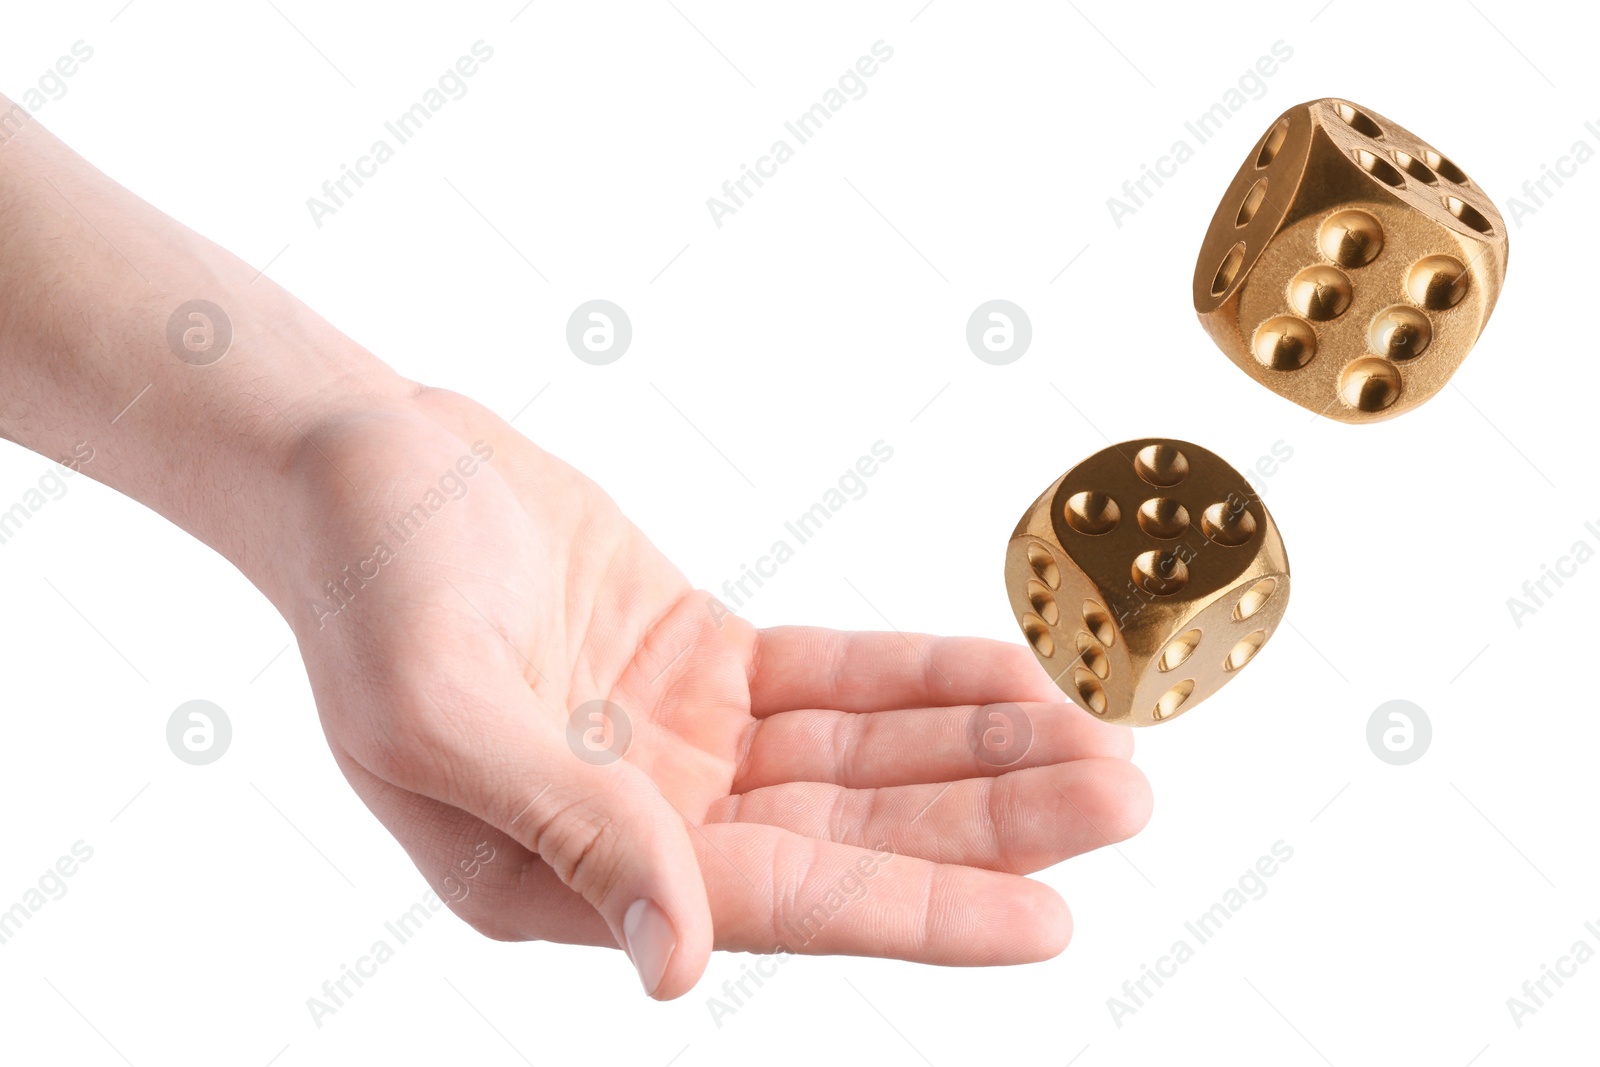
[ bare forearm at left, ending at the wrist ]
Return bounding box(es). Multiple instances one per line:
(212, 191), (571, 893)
(0, 98), (414, 585)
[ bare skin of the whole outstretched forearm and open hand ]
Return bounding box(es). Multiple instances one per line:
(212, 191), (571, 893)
(0, 98), (1150, 1000)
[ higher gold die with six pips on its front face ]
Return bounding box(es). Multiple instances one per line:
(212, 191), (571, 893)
(1194, 99), (1507, 422)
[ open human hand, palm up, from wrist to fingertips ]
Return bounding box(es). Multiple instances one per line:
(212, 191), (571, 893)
(253, 390), (1150, 1000)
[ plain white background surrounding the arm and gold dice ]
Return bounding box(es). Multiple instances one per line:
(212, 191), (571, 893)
(0, 0), (1600, 1067)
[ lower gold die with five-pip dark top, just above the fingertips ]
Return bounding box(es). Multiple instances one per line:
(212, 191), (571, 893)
(1005, 438), (1290, 726)
